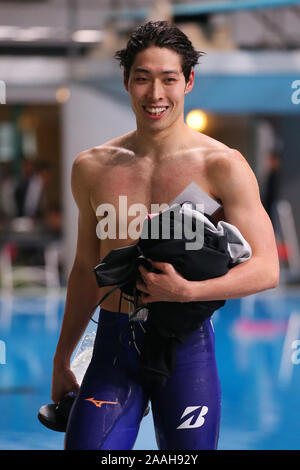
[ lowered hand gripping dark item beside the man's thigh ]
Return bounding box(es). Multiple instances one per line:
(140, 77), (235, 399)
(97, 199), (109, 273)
(51, 366), (79, 403)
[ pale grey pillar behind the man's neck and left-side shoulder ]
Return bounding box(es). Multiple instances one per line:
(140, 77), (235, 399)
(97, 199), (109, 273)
(61, 85), (136, 278)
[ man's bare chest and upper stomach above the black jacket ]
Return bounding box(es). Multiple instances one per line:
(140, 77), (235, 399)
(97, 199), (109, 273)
(91, 159), (223, 249)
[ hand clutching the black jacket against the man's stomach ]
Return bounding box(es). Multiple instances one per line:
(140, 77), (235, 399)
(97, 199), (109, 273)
(136, 260), (189, 304)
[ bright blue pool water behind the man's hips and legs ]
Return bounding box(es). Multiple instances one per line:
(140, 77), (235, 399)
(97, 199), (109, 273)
(0, 287), (300, 450)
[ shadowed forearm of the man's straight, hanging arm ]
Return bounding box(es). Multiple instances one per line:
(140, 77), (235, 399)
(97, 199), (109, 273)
(54, 268), (100, 365)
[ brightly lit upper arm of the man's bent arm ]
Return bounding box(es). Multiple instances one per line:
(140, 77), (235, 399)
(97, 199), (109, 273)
(212, 150), (278, 271)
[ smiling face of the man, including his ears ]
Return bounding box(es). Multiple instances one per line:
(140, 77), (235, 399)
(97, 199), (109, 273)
(124, 46), (194, 131)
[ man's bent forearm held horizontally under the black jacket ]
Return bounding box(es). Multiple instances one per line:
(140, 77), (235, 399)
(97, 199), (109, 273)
(186, 258), (278, 302)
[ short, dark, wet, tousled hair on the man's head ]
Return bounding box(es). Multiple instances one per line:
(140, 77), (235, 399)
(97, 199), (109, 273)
(114, 21), (204, 82)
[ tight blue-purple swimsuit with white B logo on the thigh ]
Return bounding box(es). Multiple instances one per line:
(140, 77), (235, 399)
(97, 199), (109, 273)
(65, 308), (221, 450)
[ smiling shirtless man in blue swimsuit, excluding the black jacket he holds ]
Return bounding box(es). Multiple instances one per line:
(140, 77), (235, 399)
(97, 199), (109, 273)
(52, 22), (279, 450)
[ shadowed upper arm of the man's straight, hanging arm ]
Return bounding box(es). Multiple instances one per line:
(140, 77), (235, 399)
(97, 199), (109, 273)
(71, 152), (100, 269)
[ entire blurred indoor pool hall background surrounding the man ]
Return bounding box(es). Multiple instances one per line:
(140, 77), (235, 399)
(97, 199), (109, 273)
(0, 0), (300, 450)
